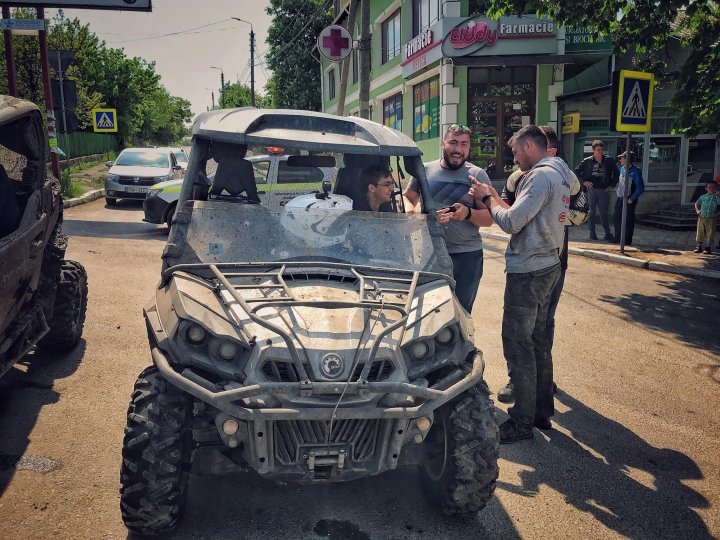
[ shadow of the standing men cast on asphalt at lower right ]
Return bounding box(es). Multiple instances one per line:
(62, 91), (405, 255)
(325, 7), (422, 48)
(498, 391), (710, 539)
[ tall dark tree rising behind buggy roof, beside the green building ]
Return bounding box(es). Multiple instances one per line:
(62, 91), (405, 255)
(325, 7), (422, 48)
(265, 0), (332, 111)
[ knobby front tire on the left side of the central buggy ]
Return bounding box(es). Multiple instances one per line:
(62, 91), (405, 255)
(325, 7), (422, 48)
(120, 367), (193, 535)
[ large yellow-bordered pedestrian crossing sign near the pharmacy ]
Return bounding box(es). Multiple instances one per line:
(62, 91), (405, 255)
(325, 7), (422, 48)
(610, 69), (655, 133)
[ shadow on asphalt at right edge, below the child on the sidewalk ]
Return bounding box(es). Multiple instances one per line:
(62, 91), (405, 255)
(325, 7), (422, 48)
(599, 279), (720, 362)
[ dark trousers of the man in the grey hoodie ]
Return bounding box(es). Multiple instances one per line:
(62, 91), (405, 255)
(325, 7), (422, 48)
(502, 264), (560, 425)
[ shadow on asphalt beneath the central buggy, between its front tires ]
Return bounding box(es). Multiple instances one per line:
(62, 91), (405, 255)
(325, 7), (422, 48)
(128, 458), (520, 540)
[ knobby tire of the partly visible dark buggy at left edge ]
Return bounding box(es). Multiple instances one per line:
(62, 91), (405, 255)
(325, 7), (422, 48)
(38, 261), (87, 352)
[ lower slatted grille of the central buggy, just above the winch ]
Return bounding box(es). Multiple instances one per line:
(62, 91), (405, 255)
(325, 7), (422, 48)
(273, 419), (381, 465)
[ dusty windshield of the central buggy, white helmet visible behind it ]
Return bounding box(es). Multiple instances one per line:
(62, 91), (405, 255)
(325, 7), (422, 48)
(168, 145), (449, 273)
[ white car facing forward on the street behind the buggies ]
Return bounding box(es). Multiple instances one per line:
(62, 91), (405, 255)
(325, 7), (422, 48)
(105, 148), (183, 206)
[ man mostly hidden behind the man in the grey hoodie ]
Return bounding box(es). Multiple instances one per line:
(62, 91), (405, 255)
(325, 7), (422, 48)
(498, 126), (581, 404)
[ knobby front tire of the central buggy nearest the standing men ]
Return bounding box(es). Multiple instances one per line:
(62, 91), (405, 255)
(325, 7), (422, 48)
(422, 382), (500, 515)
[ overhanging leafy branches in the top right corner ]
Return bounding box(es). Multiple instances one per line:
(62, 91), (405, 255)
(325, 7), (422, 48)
(483, 0), (720, 135)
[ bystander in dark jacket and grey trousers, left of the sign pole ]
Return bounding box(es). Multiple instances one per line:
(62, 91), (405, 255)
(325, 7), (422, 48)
(575, 140), (620, 240)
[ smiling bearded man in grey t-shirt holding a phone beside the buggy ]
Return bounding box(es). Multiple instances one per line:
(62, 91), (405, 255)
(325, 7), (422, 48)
(403, 124), (493, 313)
